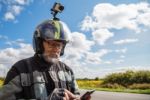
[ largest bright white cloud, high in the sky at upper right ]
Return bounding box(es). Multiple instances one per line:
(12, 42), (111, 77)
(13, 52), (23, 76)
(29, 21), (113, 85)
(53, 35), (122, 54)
(81, 2), (150, 32)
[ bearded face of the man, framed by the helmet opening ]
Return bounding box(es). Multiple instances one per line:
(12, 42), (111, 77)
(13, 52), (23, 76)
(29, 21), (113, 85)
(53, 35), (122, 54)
(43, 40), (63, 62)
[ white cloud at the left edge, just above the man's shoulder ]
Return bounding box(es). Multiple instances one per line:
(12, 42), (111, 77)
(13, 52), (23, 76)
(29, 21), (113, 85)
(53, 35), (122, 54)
(0, 43), (34, 76)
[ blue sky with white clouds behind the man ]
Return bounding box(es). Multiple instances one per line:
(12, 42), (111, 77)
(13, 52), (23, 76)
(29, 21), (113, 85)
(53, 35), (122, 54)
(0, 0), (150, 78)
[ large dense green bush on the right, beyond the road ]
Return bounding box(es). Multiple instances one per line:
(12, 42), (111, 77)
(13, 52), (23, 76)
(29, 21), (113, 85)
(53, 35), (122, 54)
(103, 70), (150, 87)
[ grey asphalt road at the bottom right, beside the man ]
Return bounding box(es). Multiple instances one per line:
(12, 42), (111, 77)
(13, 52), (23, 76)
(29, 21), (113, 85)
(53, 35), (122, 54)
(81, 90), (150, 100)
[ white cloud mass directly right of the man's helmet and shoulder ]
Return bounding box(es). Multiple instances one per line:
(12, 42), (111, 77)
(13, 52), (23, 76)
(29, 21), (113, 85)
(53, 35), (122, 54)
(62, 24), (112, 78)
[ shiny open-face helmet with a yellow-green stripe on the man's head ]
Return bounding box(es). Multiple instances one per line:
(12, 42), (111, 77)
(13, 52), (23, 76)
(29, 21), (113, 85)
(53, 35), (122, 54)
(33, 20), (68, 56)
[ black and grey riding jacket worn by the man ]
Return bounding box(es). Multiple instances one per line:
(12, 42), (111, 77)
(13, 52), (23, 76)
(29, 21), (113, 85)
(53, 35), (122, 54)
(0, 55), (79, 100)
